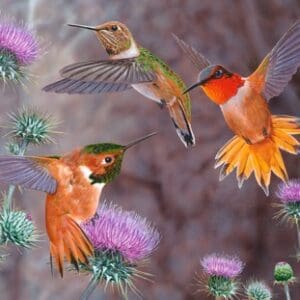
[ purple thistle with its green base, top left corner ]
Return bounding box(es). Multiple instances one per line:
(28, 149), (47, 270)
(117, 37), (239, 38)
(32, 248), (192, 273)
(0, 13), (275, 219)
(0, 21), (39, 82)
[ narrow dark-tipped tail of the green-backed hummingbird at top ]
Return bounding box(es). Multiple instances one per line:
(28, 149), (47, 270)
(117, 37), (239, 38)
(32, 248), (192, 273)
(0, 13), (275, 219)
(167, 100), (196, 148)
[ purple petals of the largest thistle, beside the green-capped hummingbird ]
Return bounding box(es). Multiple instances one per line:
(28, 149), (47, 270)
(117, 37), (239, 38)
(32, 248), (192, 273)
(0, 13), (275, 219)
(83, 203), (160, 262)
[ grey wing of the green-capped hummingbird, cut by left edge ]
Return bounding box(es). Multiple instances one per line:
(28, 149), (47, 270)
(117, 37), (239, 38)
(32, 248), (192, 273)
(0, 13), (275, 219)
(0, 155), (57, 194)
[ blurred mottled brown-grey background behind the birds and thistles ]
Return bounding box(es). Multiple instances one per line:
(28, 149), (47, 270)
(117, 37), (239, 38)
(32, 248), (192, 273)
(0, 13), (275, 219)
(0, 0), (300, 300)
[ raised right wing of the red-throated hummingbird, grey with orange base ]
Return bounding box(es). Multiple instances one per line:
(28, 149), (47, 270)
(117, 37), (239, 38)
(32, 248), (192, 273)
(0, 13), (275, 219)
(249, 20), (300, 100)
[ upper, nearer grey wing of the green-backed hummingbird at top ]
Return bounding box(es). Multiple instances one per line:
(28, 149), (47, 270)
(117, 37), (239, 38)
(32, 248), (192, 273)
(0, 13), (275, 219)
(60, 59), (156, 84)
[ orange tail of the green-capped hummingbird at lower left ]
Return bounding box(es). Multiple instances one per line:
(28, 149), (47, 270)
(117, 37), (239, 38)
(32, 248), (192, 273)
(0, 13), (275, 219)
(50, 215), (94, 277)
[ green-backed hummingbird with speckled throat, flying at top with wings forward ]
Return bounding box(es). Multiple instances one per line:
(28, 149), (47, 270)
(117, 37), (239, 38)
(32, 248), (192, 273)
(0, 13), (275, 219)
(43, 21), (195, 147)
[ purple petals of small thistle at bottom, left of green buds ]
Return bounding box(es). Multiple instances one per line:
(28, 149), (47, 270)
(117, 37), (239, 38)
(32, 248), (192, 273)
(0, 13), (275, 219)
(200, 254), (244, 279)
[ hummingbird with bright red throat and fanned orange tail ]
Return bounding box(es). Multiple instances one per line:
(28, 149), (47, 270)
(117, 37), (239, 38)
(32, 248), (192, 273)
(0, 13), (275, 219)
(174, 20), (300, 195)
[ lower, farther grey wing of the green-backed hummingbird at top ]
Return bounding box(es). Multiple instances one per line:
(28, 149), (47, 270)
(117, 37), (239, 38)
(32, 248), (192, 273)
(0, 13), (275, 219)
(43, 78), (131, 94)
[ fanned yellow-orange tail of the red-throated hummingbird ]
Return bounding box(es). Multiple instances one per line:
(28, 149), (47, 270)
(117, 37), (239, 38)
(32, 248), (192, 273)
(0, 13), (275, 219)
(215, 116), (300, 195)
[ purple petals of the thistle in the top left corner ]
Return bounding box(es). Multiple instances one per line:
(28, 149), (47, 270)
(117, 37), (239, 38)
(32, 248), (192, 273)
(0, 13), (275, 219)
(0, 21), (39, 65)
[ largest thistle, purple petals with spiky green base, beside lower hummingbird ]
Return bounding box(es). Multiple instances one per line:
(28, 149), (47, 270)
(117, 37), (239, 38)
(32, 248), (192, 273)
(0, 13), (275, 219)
(80, 204), (160, 299)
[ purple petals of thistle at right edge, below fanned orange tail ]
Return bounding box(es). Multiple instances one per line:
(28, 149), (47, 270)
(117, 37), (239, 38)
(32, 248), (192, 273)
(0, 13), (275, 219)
(276, 179), (300, 204)
